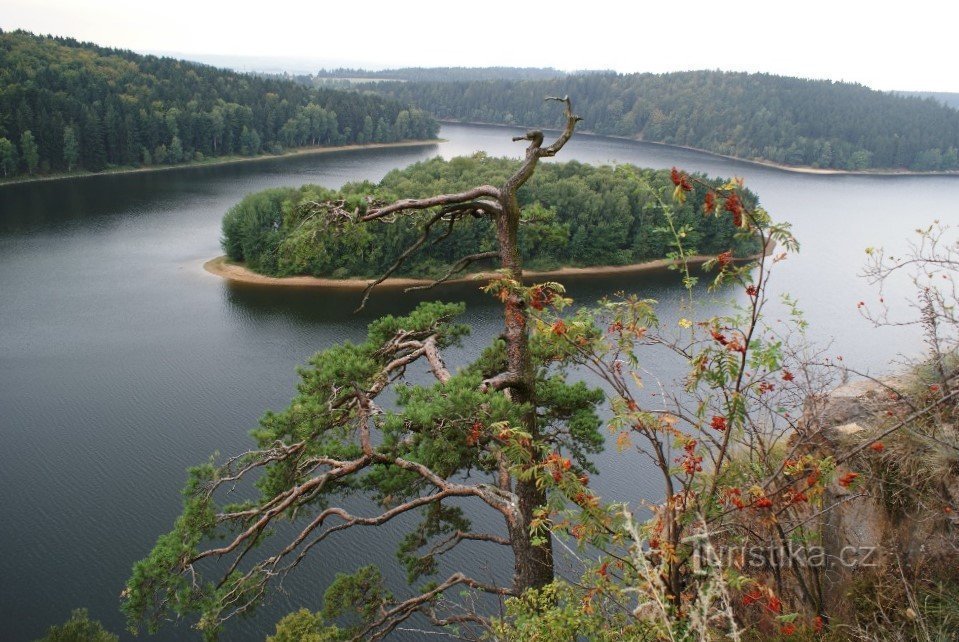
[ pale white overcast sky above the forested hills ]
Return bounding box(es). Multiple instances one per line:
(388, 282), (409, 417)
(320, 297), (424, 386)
(0, 0), (959, 92)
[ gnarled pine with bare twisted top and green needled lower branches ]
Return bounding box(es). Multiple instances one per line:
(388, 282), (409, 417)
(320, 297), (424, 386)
(124, 98), (603, 639)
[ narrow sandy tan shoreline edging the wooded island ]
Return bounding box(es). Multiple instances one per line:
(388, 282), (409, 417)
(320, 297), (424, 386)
(203, 244), (775, 290)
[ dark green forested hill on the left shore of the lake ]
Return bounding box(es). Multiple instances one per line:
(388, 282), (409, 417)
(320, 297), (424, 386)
(0, 31), (439, 176)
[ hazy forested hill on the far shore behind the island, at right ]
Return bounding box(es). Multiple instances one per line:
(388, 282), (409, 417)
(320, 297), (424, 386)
(374, 71), (959, 171)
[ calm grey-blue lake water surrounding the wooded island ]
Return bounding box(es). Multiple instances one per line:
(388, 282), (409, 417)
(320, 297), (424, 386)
(0, 126), (959, 641)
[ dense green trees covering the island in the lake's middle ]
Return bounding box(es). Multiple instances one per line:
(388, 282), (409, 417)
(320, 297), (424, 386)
(223, 154), (758, 278)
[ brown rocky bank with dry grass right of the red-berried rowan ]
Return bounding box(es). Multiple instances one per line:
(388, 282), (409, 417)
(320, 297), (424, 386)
(804, 377), (959, 602)
